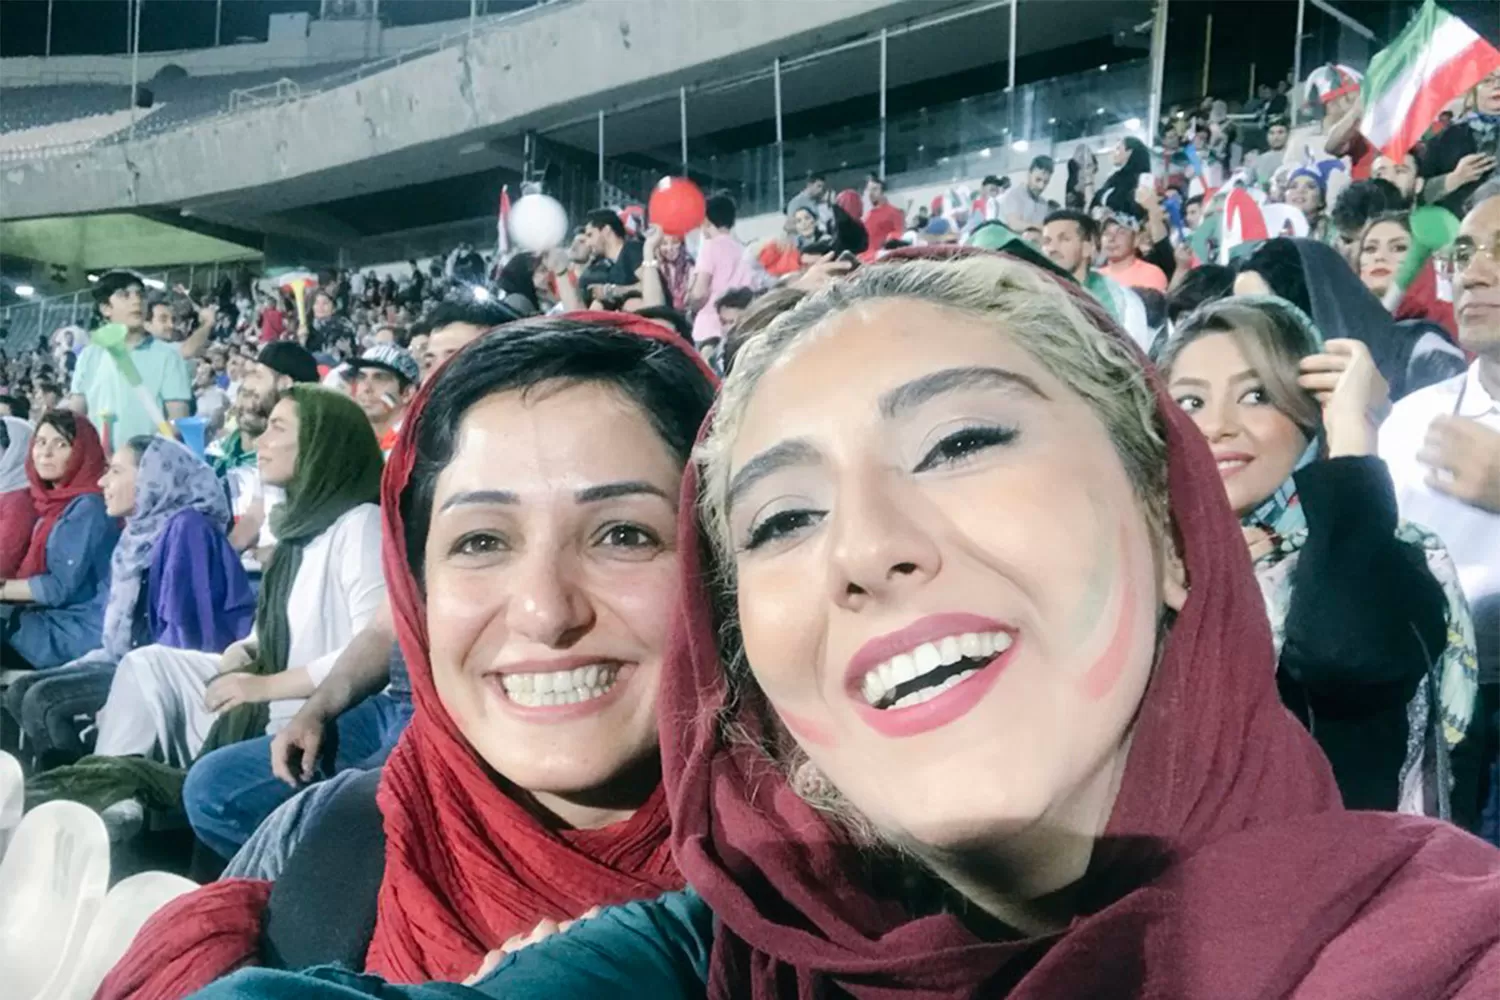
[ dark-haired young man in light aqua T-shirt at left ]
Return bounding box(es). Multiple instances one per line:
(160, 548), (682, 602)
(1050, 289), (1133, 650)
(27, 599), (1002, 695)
(69, 271), (192, 442)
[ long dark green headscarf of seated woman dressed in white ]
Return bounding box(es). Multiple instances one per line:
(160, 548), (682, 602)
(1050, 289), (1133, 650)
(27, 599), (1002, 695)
(204, 385), (383, 753)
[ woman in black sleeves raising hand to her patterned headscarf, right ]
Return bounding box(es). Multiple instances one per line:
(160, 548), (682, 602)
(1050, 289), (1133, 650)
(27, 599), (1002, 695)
(1161, 297), (1476, 814)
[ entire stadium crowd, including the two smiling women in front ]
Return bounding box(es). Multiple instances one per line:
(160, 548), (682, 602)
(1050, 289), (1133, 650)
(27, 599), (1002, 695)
(0, 56), (1500, 1000)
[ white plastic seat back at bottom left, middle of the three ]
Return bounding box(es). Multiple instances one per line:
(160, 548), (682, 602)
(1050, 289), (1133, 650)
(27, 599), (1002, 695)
(0, 802), (110, 1000)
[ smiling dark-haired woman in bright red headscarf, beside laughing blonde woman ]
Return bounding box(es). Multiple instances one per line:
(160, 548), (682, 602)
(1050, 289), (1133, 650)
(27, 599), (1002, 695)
(99, 313), (714, 1000)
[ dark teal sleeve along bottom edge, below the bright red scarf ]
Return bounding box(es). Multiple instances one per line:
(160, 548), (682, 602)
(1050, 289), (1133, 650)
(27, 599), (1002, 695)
(194, 889), (714, 1000)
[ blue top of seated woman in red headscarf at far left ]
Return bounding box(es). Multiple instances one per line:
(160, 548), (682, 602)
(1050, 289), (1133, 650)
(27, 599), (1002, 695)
(11, 493), (120, 667)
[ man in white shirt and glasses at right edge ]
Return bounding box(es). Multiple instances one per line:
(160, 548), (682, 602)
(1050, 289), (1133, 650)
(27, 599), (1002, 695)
(1380, 195), (1500, 841)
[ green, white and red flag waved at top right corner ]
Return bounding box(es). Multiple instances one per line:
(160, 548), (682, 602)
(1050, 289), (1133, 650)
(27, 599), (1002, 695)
(1359, 0), (1500, 160)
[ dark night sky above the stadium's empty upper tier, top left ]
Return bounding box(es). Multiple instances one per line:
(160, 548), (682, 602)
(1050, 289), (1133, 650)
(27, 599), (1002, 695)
(0, 0), (527, 55)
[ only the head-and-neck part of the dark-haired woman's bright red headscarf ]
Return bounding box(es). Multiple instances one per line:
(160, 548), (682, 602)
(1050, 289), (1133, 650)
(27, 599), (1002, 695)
(366, 312), (714, 982)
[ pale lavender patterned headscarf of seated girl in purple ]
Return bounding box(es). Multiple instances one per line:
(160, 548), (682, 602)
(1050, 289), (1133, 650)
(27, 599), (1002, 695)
(102, 436), (230, 663)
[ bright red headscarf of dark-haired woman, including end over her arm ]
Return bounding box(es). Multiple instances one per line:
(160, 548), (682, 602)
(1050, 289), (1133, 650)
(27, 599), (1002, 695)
(95, 312), (717, 1000)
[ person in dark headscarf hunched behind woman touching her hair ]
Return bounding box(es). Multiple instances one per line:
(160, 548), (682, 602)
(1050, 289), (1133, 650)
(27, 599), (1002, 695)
(1235, 237), (1464, 400)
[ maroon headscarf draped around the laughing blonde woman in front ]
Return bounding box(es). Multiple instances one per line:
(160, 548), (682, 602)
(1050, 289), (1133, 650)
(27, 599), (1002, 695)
(659, 250), (1500, 1000)
